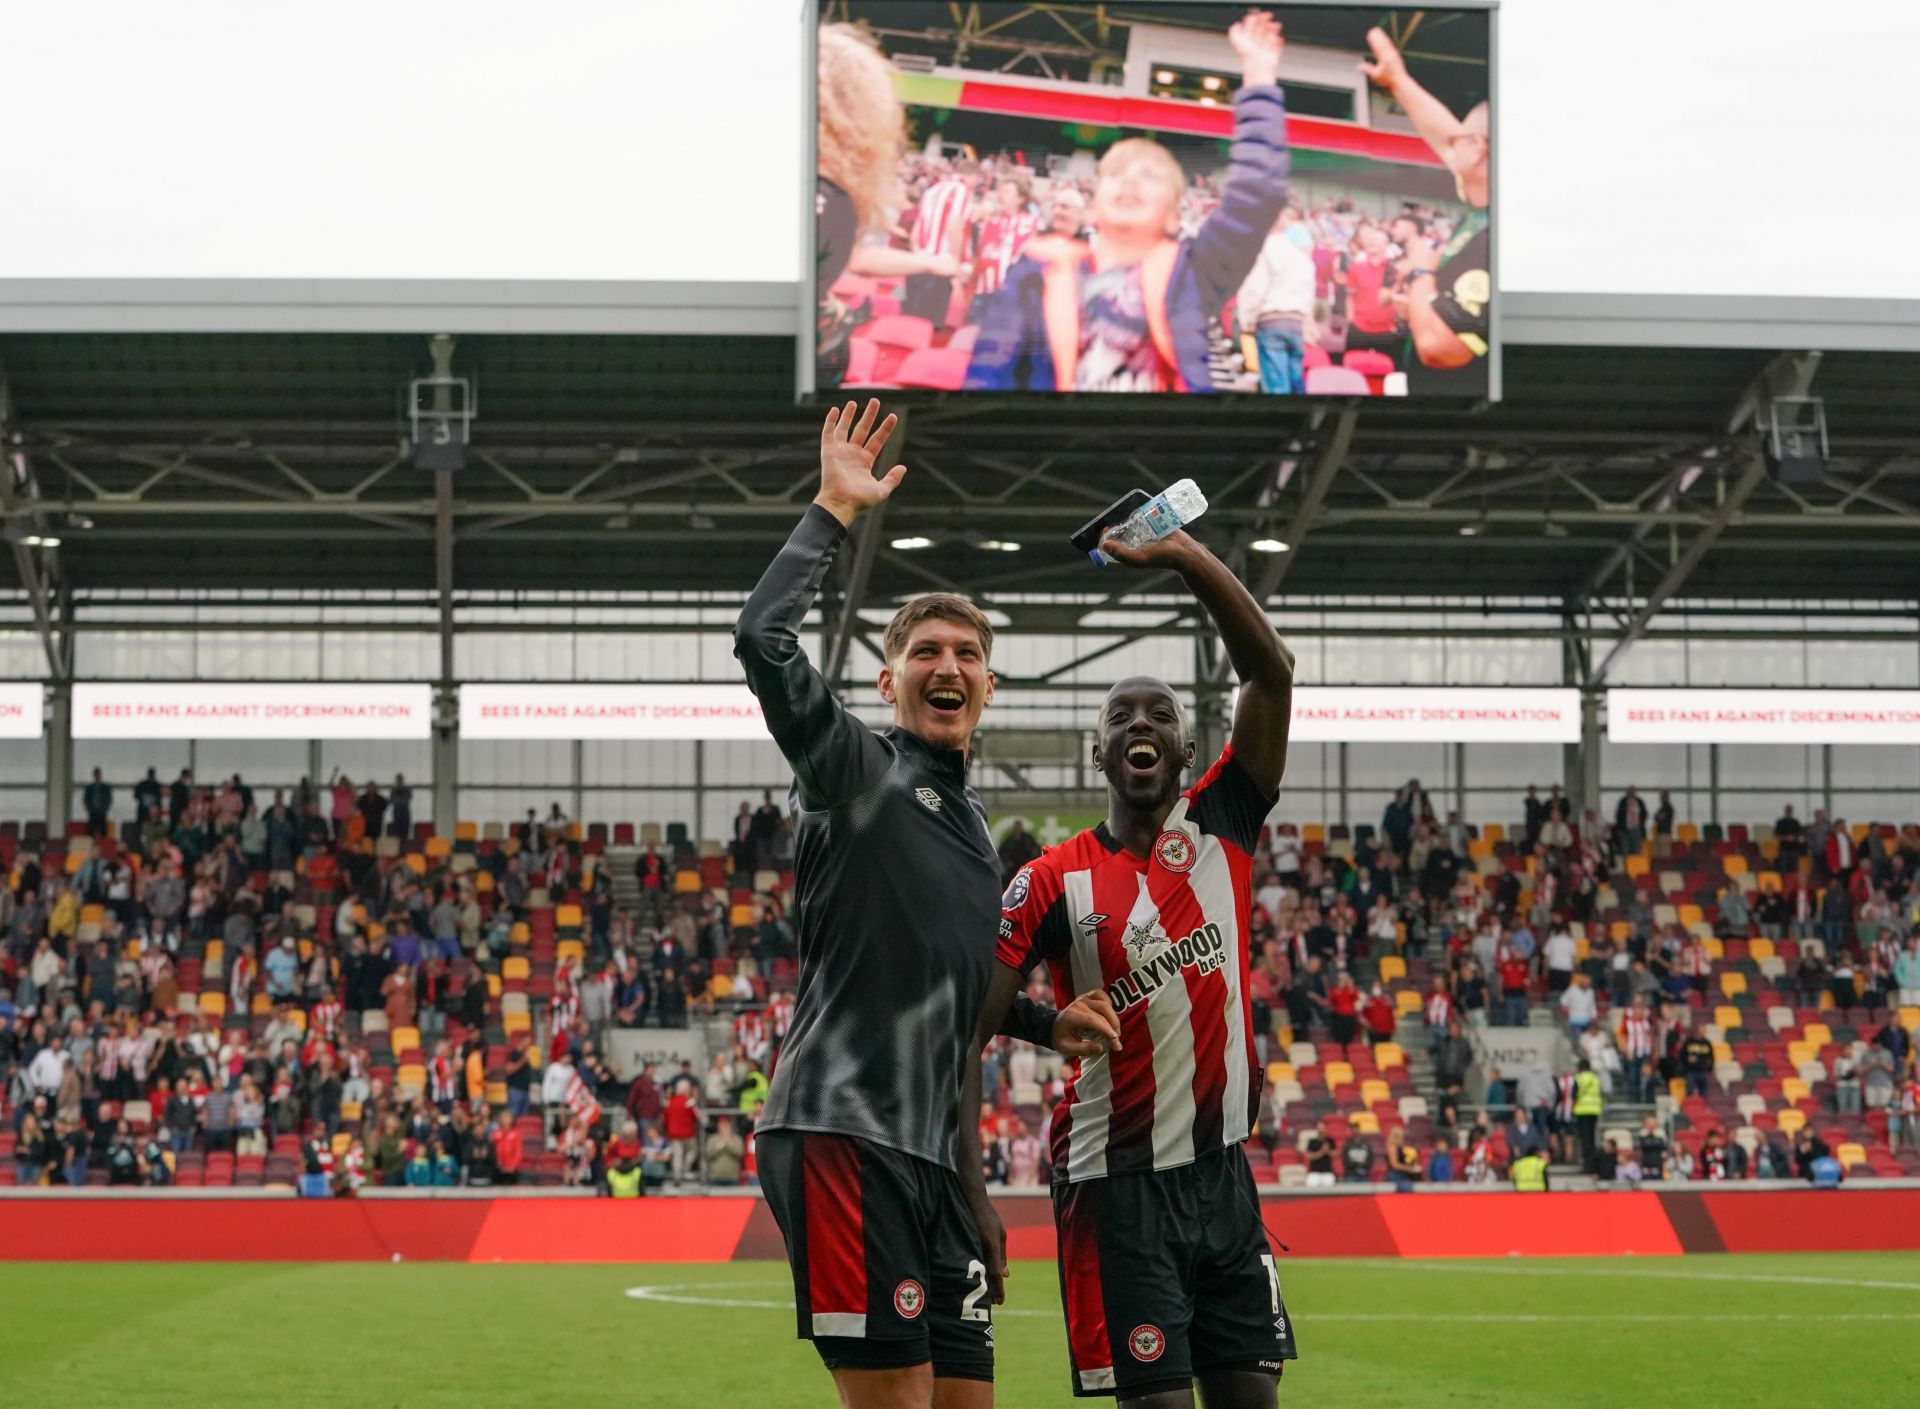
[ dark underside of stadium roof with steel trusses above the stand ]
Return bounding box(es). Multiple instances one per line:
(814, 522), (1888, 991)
(0, 334), (1920, 625)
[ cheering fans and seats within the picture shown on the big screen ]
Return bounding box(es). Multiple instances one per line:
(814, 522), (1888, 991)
(816, 12), (1494, 397)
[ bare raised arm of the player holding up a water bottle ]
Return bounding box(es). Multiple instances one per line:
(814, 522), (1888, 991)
(1100, 532), (1294, 797)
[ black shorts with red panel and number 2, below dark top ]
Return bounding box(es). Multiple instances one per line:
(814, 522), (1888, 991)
(755, 1131), (993, 1382)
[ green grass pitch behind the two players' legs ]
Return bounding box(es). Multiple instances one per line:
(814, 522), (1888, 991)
(0, 1254), (1920, 1409)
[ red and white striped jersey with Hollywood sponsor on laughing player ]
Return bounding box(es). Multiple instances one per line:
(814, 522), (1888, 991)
(998, 747), (1273, 1182)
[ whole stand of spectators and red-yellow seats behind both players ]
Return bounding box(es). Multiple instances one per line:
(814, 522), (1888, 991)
(0, 774), (1920, 1196)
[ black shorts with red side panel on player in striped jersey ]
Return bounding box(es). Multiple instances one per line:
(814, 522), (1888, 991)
(1054, 1146), (1298, 1396)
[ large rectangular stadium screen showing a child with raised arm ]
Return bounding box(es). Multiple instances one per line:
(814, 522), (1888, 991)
(801, 0), (1500, 401)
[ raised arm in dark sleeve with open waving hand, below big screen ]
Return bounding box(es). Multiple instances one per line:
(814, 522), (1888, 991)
(733, 401), (906, 808)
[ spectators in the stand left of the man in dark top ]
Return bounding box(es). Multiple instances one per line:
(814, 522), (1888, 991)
(0, 770), (793, 1192)
